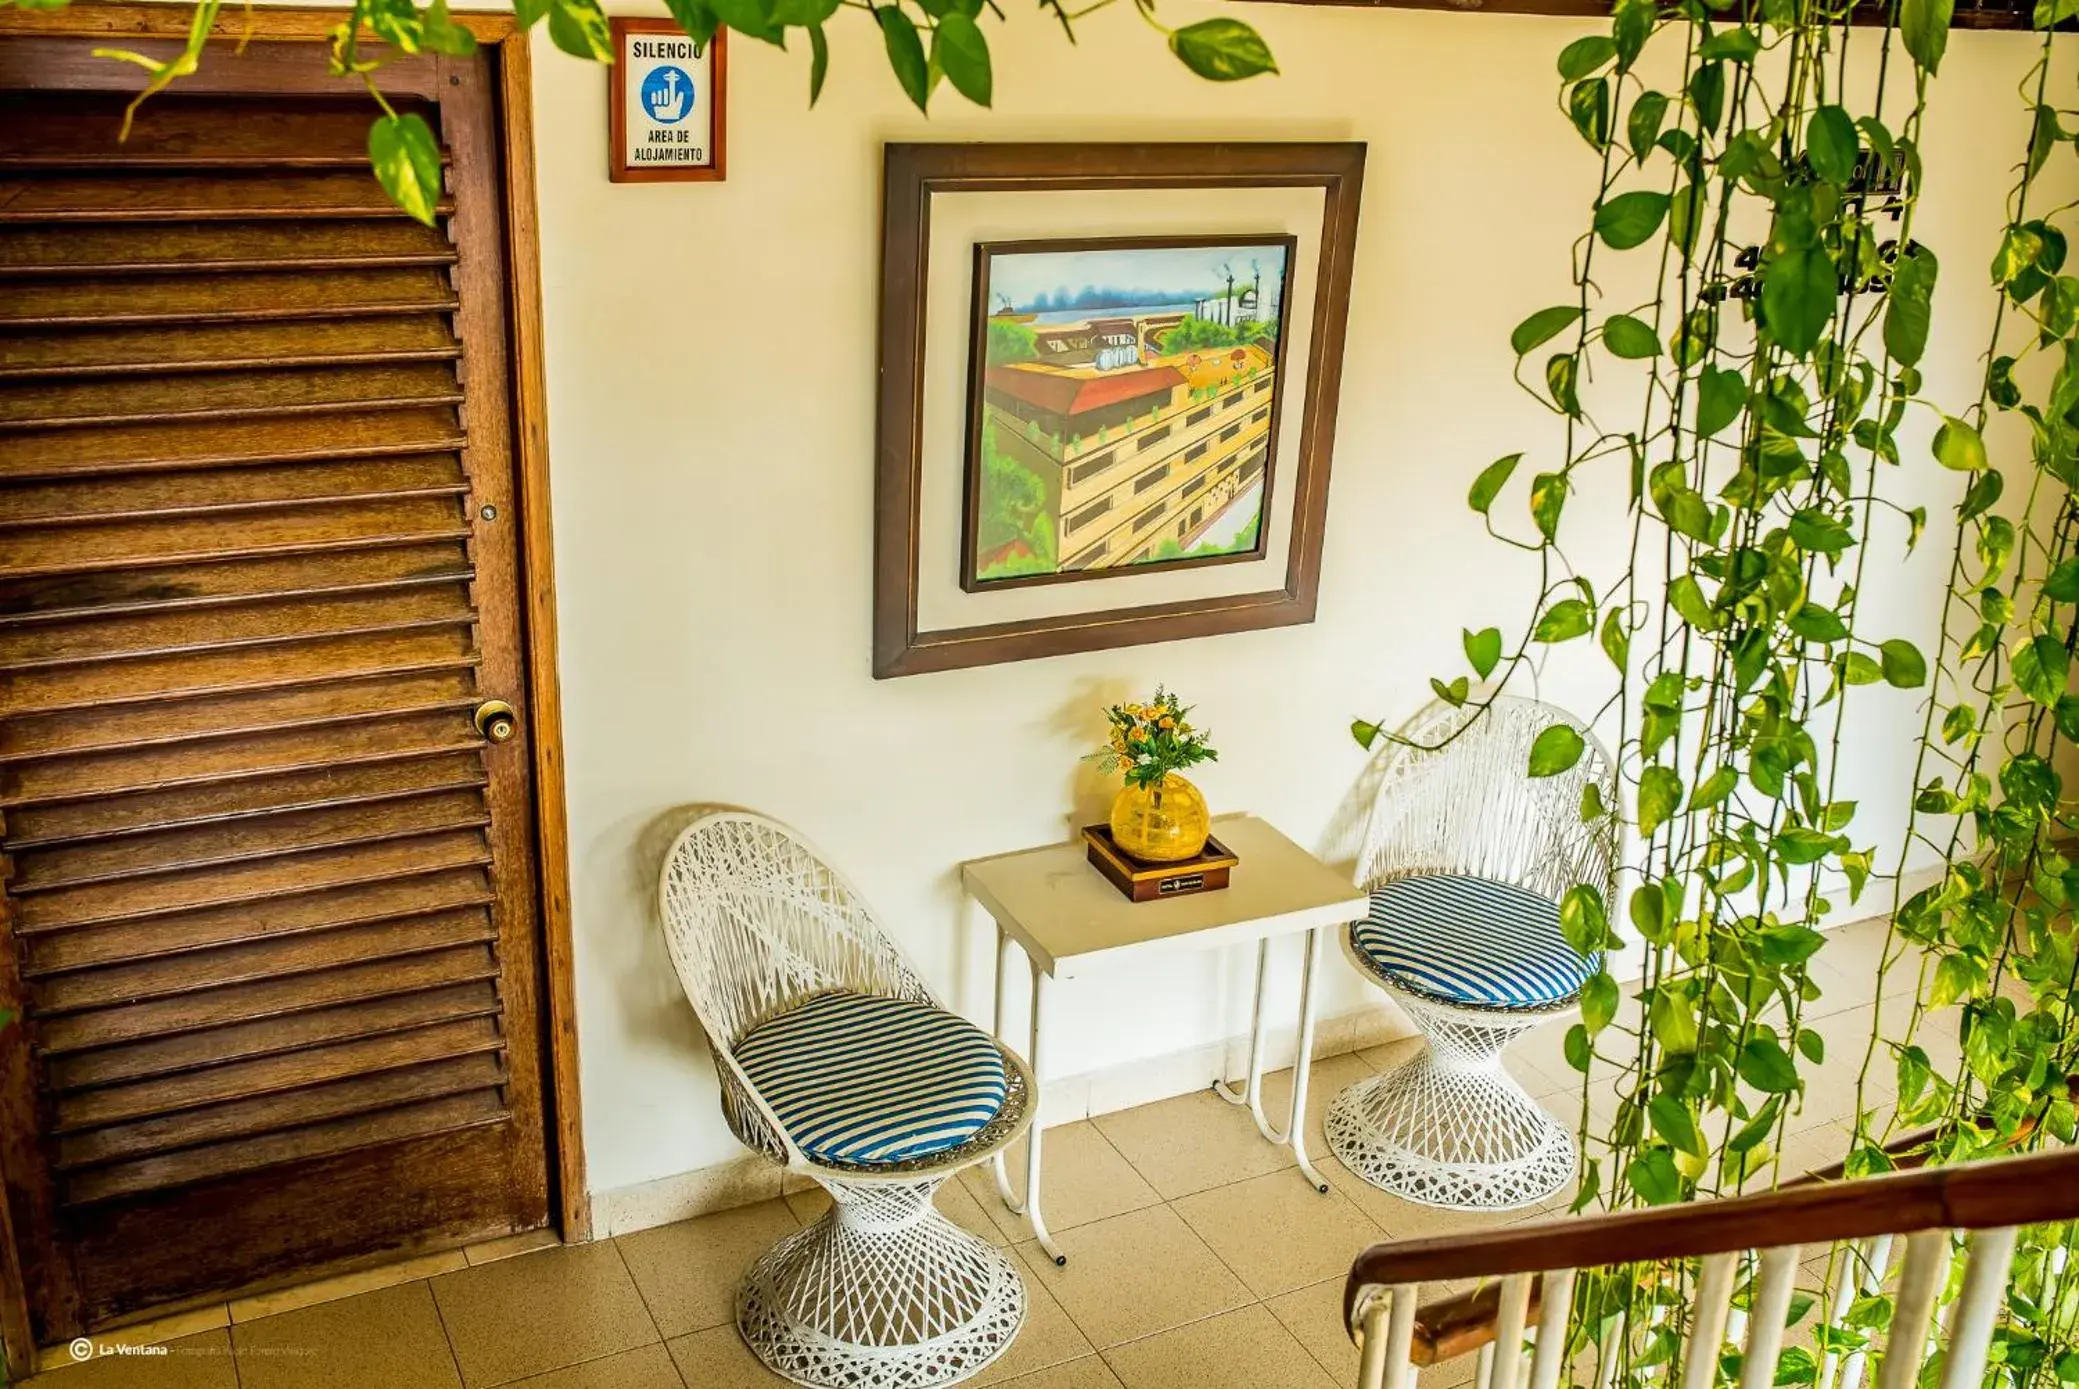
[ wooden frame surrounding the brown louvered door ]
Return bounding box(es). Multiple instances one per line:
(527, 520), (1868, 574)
(0, 0), (593, 1379)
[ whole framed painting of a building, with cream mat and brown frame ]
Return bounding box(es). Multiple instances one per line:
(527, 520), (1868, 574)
(873, 143), (1364, 678)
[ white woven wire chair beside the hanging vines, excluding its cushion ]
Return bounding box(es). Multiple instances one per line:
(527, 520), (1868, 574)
(1326, 697), (1617, 1210)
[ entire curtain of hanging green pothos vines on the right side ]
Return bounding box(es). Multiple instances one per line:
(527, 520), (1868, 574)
(1353, 0), (2079, 1385)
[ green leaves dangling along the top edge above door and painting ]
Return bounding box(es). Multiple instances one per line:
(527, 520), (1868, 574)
(0, 0), (1279, 227)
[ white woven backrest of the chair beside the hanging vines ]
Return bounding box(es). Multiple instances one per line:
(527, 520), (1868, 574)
(1358, 695), (1617, 900)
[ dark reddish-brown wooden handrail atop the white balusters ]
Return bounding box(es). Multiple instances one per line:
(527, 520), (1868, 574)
(1343, 1150), (2079, 1347)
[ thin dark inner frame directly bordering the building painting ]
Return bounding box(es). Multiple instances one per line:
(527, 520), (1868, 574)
(960, 231), (1308, 593)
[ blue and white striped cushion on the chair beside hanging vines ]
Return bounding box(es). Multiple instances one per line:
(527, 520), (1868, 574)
(1349, 873), (1597, 1008)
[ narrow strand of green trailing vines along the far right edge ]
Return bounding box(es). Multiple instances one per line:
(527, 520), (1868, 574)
(1857, 27), (2079, 1167)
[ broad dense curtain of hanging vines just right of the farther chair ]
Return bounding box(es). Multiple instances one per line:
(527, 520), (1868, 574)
(1358, 0), (1945, 1206)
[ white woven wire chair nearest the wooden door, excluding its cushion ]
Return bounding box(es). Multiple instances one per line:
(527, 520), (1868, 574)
(659, 811), (1035, 1389)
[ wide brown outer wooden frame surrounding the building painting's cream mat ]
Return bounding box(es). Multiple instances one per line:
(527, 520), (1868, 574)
(873, 141), (1364, 680)
